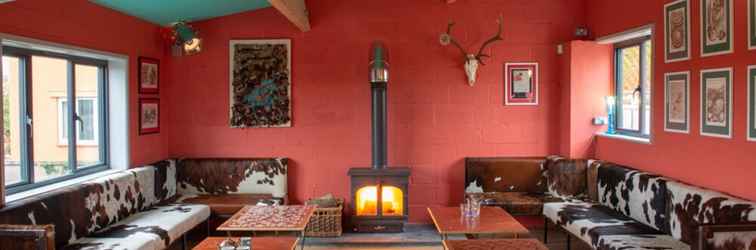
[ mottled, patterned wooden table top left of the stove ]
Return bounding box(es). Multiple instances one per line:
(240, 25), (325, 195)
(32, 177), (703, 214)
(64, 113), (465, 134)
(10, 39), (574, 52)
(217, 205), (316, 231)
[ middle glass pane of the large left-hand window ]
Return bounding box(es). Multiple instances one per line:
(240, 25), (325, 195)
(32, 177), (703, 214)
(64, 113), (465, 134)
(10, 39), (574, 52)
(31, 56), (70, 182)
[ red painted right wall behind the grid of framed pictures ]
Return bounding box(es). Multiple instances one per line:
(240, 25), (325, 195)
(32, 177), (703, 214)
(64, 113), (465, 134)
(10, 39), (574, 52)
(586, 0), (756, 200)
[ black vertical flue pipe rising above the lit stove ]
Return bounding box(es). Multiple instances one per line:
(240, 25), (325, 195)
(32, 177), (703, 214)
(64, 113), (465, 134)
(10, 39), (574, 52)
(369, 41), (389, 169)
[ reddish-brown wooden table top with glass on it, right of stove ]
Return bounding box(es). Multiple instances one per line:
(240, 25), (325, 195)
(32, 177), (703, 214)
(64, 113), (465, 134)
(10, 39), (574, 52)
(428, 207), (529, 235)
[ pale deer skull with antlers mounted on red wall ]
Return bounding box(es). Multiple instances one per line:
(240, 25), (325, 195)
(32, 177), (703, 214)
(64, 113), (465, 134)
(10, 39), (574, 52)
(440, 16), (504, 87)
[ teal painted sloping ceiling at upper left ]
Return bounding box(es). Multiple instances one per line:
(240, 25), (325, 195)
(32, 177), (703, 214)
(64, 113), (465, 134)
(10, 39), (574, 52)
(90, 0), (270, 26)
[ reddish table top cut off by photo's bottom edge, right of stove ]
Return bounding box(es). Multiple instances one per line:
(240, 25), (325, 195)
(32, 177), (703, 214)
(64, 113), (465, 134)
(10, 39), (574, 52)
(443, 239), (549, 250)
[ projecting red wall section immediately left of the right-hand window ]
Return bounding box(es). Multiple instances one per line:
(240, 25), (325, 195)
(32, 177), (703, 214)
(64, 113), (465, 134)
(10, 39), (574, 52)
(559, 41), (612, 158)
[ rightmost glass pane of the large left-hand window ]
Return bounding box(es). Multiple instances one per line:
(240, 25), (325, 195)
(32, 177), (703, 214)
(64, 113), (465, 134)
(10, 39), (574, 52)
(74, 65), (103, 167)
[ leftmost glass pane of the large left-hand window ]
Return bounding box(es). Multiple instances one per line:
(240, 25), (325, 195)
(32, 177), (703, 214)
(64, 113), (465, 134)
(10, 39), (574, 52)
(2, 56), (23, 185)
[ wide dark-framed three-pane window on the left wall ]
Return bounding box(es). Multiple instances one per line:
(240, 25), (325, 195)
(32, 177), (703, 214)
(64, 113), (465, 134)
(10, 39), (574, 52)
(2, 46), (108, 194)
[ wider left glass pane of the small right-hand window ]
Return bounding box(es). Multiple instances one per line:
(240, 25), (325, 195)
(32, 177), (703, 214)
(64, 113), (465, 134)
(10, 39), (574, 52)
(618, 46), (641, 131)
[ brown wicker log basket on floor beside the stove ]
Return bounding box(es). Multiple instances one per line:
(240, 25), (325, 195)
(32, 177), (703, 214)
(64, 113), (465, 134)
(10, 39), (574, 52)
(305, 199), (344, 237)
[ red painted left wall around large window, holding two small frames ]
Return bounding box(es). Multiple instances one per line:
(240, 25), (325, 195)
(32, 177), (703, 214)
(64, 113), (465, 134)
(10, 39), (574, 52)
(0, 0), (168, 166)
